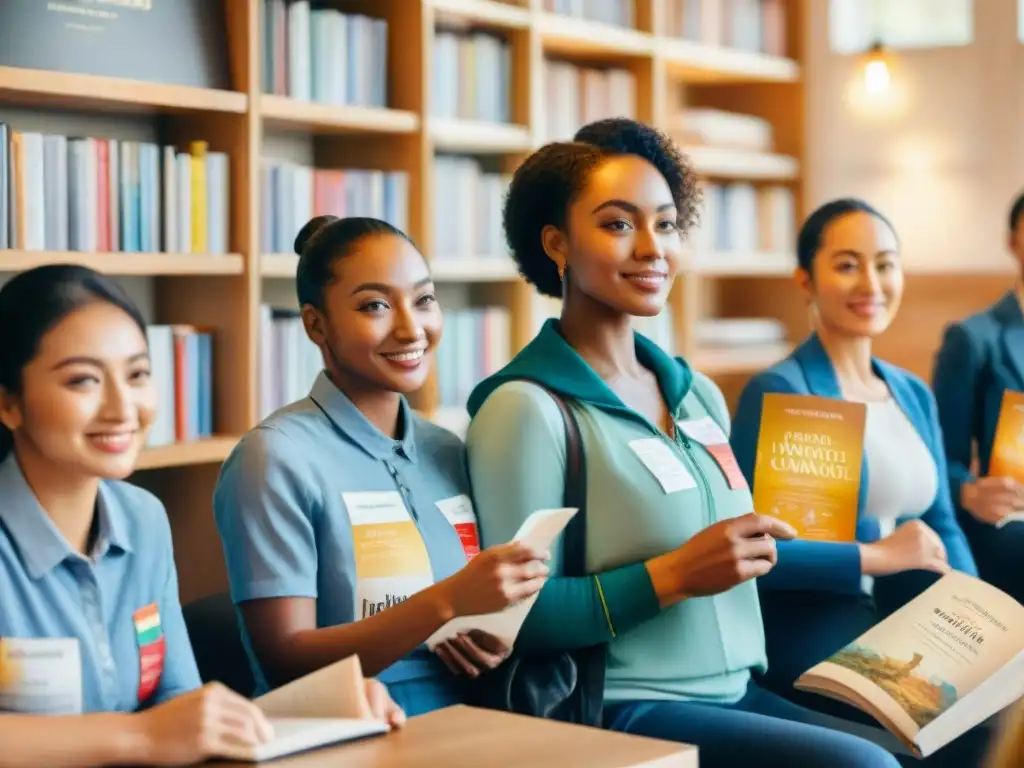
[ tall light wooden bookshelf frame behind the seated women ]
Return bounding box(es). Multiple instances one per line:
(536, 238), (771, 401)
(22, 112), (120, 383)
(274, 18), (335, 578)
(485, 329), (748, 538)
(0, 0), (804, 599)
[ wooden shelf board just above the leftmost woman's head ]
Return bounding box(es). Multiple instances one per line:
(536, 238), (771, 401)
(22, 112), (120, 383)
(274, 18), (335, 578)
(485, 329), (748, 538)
(0, 250), (245, 276)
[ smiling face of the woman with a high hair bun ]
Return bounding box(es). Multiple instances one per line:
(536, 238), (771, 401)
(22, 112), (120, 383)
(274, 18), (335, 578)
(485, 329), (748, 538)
(302, 234), (443, 393)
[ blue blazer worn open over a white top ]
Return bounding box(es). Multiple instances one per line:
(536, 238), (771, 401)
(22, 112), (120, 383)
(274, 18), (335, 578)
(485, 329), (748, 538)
(730, 334), (978, 594)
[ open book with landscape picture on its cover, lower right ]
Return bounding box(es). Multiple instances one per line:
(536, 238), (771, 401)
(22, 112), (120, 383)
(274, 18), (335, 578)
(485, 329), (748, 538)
(796, 571), (1024, 758)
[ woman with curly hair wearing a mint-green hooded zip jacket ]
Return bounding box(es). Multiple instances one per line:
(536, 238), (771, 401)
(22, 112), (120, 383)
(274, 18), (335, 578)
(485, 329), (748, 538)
(467, 119), (898, 768)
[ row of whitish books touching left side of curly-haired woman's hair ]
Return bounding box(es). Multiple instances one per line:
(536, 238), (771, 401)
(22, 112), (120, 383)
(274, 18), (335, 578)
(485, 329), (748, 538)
(434, 155), (511, 259)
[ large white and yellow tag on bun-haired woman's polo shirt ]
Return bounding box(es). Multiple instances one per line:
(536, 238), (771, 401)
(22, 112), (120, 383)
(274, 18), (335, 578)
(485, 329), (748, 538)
(341, 490), (434, 618)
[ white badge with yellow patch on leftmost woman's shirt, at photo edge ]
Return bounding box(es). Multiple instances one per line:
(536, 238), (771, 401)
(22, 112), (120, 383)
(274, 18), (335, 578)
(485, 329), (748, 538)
(0, 637), (82, 715)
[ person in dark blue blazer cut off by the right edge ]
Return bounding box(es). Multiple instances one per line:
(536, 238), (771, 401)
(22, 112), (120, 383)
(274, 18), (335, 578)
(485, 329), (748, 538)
(932, 195), (1024, 601)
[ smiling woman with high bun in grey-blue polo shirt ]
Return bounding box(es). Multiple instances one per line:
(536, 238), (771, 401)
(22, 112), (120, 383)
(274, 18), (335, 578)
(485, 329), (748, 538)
(214, 216), (547, 715)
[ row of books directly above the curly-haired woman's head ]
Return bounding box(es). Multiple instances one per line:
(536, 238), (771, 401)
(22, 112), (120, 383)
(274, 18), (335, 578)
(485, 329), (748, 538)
(544, 59), (637, 141)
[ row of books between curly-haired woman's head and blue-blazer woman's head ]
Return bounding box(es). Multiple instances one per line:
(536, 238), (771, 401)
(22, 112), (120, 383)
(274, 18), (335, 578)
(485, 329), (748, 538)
(688, 182), (797, 253)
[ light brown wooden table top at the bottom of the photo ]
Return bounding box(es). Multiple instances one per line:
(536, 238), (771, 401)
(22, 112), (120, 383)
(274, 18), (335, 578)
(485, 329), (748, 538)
(220, 707), (697, 768)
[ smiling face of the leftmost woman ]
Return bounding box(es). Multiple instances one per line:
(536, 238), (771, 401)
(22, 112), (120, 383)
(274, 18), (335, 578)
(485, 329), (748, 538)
(0, 301), (157, 479)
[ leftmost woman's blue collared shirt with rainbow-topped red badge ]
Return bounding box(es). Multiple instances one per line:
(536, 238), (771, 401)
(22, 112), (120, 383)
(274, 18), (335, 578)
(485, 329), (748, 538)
(0, 454), (201, 712)
